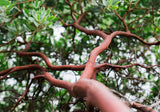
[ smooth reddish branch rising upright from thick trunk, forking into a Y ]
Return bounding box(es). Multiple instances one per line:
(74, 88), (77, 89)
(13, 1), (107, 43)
(56, 7), (160, 78)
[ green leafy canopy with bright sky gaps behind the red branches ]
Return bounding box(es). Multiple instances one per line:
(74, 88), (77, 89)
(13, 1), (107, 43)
(0, 0), (160, 112)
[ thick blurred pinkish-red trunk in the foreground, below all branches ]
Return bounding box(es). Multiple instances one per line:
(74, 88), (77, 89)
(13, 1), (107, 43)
(72, 79), (130, 112)
